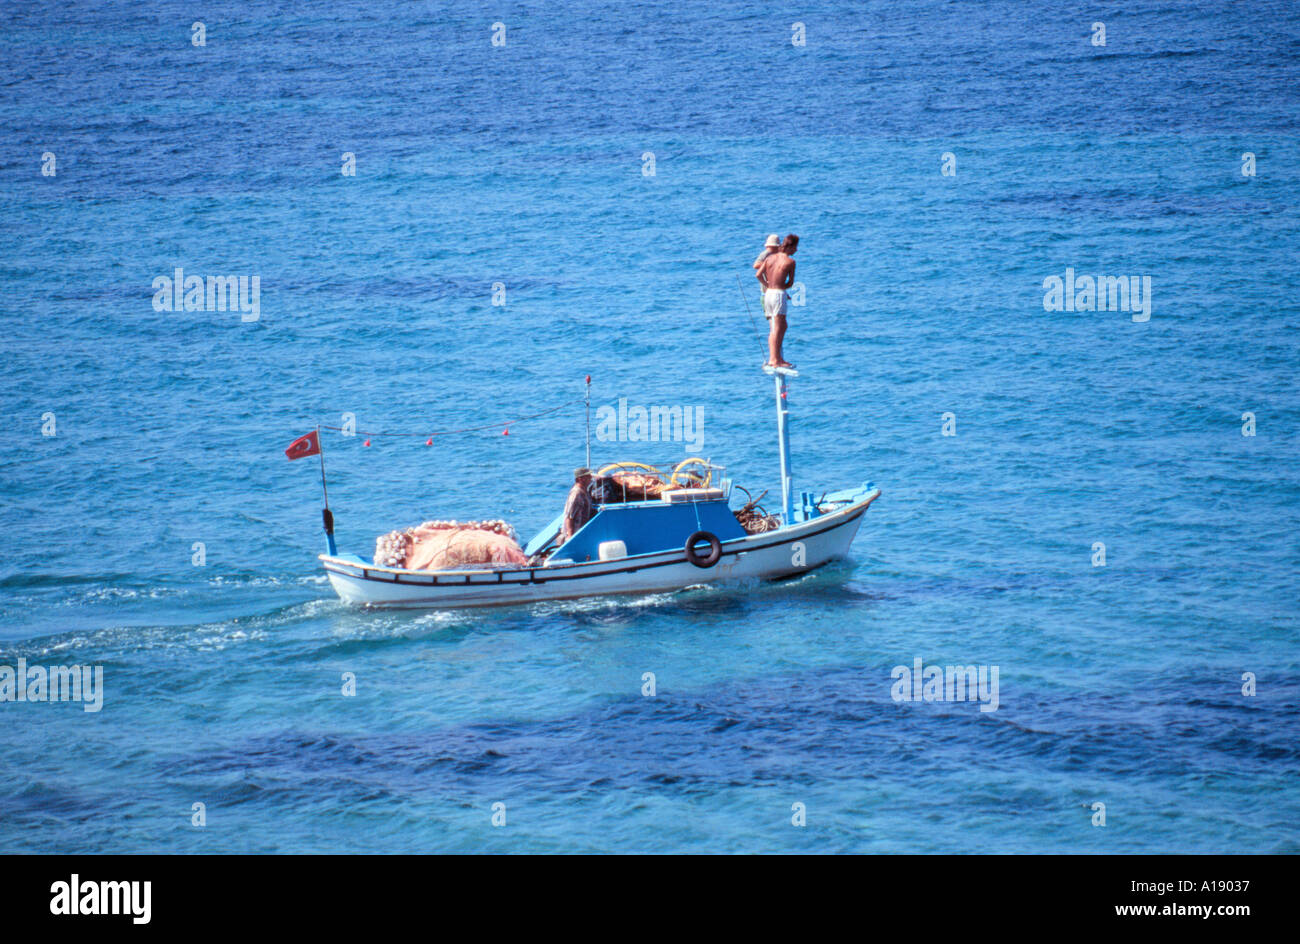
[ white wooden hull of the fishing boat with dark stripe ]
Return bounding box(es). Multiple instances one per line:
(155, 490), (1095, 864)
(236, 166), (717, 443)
(320, 489), (880, 607)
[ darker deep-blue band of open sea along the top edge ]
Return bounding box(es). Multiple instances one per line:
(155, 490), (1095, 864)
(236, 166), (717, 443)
(0, 1), (1296, 168)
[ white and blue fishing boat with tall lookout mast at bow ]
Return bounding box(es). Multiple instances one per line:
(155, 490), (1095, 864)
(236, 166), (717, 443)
(315, 367), (880, 609)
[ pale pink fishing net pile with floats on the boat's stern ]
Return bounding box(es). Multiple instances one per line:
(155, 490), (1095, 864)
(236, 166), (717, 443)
(374, 520), (528, 571)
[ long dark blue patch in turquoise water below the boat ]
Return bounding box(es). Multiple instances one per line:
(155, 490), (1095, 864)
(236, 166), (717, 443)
(149, 667), (1300, 802)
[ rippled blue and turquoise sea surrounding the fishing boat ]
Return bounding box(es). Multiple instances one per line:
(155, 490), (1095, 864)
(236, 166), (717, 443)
(0, 0), (1300, 853)
